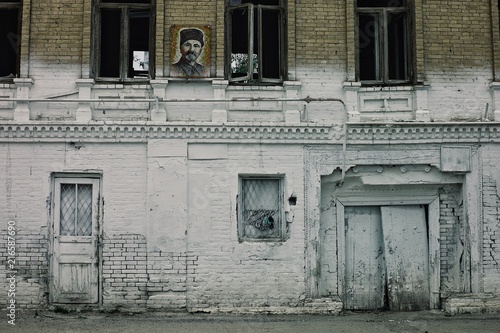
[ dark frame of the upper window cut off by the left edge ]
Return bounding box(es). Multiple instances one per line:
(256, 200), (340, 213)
(0, 0), (22, 82)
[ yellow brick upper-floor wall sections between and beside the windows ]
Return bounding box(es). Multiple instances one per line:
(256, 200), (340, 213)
(21, 0), (499, 91)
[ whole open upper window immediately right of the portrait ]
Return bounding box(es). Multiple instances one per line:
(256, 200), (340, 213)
(226, 0), (286, 84)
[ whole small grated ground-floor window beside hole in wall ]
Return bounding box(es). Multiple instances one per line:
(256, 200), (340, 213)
(238, 177), (284, 241)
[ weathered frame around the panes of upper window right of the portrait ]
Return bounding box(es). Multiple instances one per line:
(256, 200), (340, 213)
(225, 0), (286, 85)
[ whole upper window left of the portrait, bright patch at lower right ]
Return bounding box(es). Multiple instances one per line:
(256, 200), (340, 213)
(94, 0), (154, 82)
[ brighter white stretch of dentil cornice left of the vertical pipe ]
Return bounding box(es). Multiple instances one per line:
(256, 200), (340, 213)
(0, 122), (342, 143)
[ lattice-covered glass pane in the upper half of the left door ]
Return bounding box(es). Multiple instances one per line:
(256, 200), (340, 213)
(59, 184), (92, 236)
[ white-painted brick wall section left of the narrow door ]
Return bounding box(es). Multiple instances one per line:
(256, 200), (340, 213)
(0, 143), (63, 308)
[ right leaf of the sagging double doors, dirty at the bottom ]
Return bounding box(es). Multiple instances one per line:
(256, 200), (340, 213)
(380, 206), (430, 311)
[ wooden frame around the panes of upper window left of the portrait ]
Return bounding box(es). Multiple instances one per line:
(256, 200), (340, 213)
(93, 0), (155, 83)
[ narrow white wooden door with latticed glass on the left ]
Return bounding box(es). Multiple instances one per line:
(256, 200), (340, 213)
(50, 178), (99, 303)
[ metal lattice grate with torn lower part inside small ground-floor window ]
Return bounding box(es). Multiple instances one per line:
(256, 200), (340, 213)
(242, 179), (281, 238)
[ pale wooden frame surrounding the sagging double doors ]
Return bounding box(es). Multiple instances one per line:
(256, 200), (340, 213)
(336, 193), (441, 309)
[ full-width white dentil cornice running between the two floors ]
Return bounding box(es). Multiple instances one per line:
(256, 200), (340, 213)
(0, 121), (500, 145)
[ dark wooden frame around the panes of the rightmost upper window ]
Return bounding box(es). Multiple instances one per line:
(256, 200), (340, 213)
(355, 0), (414, 85)
